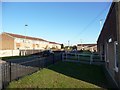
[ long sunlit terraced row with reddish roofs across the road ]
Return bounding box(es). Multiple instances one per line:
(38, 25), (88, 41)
(0, 32), (61, 55)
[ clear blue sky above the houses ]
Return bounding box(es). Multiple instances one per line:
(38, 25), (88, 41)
(2, 2), (111, 45)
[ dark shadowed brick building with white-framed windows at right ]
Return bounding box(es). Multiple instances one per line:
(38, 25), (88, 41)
(97, 1), (120, 88)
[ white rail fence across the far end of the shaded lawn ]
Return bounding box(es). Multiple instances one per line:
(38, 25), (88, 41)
(62, 53), (102, 64)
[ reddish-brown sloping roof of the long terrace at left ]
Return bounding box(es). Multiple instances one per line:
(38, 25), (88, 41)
(4, 32), (48, 42)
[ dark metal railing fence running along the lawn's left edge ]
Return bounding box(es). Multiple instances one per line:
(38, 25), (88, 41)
(2, 54), (62, 89)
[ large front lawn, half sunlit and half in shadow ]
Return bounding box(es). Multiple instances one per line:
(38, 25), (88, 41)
(7, 62), (107, 89)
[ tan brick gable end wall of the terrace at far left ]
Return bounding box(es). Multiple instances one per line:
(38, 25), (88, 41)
(0, 34), (14, 50)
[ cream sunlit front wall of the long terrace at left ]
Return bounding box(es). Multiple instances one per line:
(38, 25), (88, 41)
(14, 38), (49, 50)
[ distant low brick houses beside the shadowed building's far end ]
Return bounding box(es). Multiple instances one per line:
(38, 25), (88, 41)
(77, 44), (97, 52)
